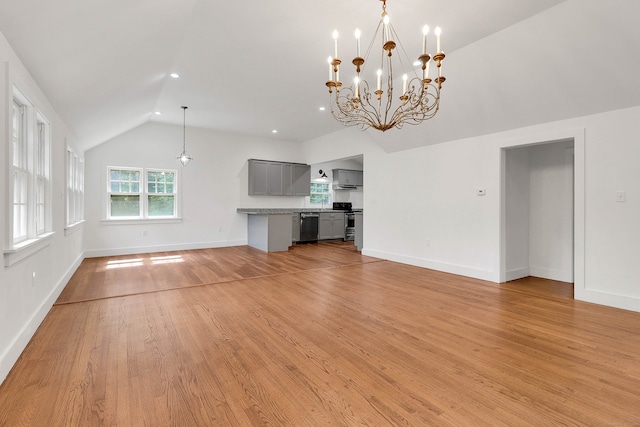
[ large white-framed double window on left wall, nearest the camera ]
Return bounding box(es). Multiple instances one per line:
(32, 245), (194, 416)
(8, 88), (51, 249)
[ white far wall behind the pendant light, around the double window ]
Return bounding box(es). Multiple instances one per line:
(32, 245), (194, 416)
(84, 123), (308, 256)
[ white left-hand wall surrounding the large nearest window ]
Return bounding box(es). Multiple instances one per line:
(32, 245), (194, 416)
(0, 30), (83, 382)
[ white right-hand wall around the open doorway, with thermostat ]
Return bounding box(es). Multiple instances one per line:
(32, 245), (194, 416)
(304, 107), (640, 311)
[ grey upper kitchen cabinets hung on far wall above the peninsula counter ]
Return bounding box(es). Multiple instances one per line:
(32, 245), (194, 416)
(249, 159), (311, 196)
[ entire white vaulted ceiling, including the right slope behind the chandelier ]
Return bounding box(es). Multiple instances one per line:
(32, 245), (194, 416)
(0, 0), (640, 154)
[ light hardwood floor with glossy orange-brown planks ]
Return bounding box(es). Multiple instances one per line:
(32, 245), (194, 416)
(0, 243), (640, 427)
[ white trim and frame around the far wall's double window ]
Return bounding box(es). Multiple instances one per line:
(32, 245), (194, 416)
(101, 166), (182, 225)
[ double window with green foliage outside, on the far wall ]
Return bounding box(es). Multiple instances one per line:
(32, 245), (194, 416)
(107, 167), (177, 219)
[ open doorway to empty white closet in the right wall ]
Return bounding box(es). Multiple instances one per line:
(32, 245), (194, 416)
(502, 139), (576, 288)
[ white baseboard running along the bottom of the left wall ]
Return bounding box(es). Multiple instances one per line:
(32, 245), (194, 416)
(0, 254), (84, 384)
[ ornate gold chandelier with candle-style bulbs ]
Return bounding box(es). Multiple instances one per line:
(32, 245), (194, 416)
(327, 0), (446, 132)
